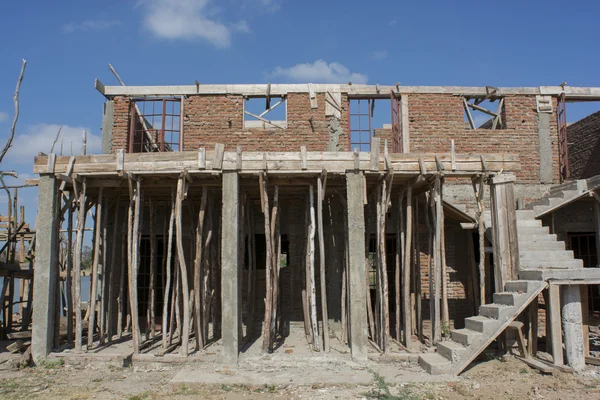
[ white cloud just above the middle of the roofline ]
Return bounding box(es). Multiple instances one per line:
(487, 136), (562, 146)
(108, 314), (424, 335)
(270, 60), (367, 84)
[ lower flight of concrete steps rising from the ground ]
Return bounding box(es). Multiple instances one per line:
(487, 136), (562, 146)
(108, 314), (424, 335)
(419, 280), (547, 375)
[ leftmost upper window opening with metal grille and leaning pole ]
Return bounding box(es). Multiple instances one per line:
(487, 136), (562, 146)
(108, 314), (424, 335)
(129, 98), (183, 153)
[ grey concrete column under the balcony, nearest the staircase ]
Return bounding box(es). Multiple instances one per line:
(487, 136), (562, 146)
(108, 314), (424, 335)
(346, 172), (368, 361)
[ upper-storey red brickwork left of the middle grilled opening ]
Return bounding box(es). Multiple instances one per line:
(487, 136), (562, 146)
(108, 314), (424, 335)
(112, 93), (350, 152)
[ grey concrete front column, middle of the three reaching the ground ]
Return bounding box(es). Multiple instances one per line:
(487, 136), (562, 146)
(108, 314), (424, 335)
(221, 172), (241, 364)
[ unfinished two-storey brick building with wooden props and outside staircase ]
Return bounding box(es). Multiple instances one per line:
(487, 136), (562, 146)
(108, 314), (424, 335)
(27, 81), (600, 374)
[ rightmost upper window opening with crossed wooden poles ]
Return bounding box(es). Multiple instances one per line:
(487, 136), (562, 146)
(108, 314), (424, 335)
(463, 95), (506, 129)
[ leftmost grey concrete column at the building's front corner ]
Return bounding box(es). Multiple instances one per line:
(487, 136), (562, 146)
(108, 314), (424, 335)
(31, 174), (59, 361)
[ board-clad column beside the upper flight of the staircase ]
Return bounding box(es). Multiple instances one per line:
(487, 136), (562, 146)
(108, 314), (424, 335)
(490, 175), (519, 293)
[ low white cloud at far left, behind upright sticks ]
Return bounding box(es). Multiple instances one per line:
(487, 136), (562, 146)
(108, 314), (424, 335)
(3, 124), (102, 164)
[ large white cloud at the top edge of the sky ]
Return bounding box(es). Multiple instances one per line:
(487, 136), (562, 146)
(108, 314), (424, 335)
(139, 0), (250, 48)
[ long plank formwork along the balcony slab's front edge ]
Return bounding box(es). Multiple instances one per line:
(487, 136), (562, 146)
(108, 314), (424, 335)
(34, 151), (520, 177)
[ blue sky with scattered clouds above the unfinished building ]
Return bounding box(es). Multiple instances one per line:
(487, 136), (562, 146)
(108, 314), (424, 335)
(0, 0), (600, 222)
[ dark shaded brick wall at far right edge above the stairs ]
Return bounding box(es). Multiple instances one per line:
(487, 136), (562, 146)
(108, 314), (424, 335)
(567, 111), (600, 179)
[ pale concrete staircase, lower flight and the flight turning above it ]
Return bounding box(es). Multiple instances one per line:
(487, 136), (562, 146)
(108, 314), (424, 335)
(419, 206), (584, 375)
